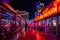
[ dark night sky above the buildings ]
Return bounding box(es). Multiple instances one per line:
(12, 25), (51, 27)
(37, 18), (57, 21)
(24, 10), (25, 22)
(10, 0), (52, 19)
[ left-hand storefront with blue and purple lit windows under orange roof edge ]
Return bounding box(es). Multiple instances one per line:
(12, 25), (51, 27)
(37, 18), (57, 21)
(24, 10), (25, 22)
(0, 2), (25, 40)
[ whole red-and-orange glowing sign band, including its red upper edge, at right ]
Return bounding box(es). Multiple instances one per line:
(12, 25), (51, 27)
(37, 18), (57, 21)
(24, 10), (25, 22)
(35, 0), (60, 21)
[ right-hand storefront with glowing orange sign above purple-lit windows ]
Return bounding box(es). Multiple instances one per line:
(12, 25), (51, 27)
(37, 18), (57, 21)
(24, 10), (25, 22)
(35, 0), (60, 36)
